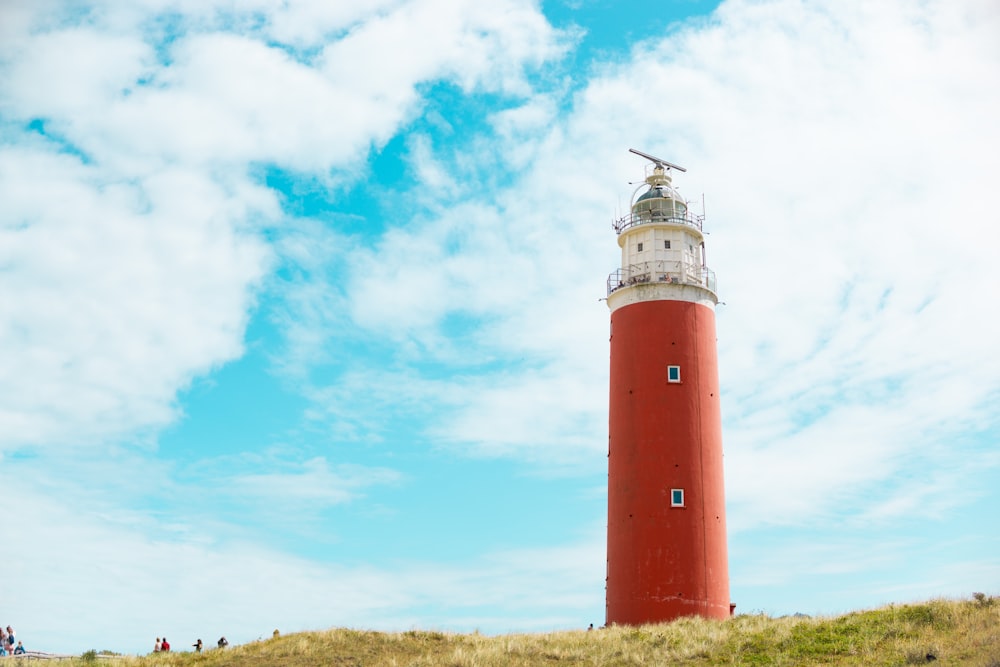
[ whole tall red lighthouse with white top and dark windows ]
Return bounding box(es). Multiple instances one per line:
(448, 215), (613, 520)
(607, 149), (730, 625)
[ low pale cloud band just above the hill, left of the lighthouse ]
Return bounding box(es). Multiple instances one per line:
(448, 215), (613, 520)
(0, 480), (602, 653)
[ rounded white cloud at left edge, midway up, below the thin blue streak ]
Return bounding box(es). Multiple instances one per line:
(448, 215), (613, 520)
(0, 146), (270, 448)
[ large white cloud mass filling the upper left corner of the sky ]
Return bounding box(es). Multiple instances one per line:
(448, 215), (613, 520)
(0, 2), (562, 454)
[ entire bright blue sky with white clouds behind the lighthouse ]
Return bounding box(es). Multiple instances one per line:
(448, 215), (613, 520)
(0, 0), (1000, 653)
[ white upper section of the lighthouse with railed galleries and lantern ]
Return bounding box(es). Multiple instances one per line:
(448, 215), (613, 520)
(608, 150), (718, 311)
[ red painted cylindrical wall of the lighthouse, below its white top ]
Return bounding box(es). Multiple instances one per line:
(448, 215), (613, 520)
(607, 300), (730, 625)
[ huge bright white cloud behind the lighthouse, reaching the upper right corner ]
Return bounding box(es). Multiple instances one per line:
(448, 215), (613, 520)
(318, 2), (1000, 525)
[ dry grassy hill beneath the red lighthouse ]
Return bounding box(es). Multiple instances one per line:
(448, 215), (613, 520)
(63, 594), (1000, 667)
